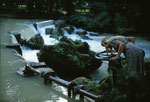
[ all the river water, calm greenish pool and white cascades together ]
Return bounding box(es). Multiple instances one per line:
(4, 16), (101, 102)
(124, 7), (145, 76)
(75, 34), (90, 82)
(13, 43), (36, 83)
(0, 18), (150, 102)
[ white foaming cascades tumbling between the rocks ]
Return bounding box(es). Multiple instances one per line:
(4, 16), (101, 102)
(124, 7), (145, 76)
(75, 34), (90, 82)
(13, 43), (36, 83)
(13, 20), (149, 62)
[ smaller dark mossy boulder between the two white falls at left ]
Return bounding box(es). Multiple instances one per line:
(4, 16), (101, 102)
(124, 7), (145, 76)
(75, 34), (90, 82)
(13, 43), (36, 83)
(24, 34), (44, 49)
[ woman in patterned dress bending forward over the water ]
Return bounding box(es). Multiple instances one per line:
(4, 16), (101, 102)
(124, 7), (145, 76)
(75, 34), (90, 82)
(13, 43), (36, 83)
(101, 36), (145, 75)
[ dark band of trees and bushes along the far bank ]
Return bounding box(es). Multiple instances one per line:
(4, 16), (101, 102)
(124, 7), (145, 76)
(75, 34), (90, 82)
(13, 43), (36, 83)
(0, 0), (150, 36)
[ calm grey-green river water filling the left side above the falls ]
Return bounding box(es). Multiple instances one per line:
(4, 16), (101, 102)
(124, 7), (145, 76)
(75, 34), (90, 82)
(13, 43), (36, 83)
(0, 18), (76, 102)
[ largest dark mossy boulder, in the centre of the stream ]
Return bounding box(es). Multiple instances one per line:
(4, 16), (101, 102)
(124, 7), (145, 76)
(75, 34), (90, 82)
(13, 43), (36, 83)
(37, 38), (102, 78)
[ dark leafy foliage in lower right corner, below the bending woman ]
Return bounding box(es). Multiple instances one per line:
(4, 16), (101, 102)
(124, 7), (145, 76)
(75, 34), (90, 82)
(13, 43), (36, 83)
(102, 60), (150, 102)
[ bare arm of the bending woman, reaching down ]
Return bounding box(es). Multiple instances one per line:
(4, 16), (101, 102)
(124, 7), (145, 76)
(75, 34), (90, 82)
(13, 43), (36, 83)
(110, 42), (125, 61)
